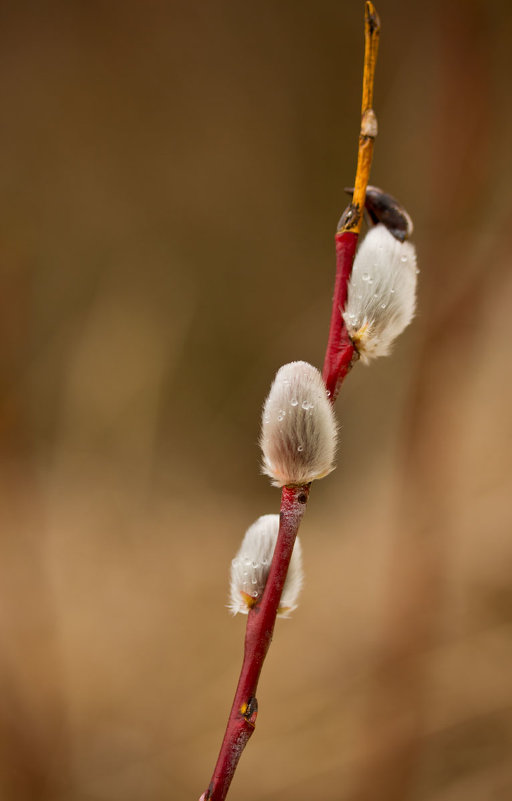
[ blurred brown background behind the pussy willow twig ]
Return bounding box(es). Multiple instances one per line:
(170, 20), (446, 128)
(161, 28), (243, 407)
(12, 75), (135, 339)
(0, 0), (512, 801)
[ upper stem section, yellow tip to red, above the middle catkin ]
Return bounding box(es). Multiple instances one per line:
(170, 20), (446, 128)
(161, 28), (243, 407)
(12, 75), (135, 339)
(323, 2), (380, 402)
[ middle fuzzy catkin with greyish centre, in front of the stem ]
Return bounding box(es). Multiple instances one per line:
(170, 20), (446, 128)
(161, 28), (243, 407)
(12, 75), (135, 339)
(260, 362), (337, 487)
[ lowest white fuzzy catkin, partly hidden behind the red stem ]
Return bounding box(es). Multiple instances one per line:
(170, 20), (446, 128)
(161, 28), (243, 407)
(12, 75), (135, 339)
(229, 515), (303, 617)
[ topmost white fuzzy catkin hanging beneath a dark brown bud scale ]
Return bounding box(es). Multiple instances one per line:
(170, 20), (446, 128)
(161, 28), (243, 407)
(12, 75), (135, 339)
(343, 224), (419, 361)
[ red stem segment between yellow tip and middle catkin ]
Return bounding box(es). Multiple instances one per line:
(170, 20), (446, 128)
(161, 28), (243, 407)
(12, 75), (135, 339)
(323, 231), (358, 396)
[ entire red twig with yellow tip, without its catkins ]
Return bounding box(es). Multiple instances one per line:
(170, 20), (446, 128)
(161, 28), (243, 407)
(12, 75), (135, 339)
(199, 2), (380, 801)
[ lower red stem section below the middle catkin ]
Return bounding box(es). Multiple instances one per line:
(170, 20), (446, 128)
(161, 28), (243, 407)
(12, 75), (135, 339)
(199, 484), (310, 801)
